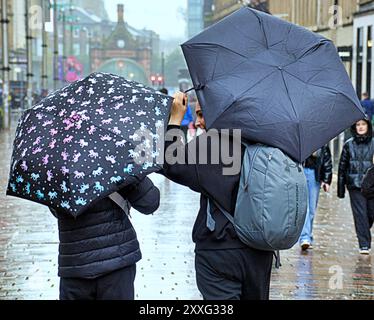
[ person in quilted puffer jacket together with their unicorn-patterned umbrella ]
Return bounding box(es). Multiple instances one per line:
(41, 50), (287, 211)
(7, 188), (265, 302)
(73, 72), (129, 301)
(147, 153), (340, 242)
(7, 73), (172, 299)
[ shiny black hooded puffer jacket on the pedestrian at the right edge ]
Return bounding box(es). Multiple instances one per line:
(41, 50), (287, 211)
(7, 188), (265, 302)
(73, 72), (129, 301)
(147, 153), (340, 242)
(338, 120), (374, 198)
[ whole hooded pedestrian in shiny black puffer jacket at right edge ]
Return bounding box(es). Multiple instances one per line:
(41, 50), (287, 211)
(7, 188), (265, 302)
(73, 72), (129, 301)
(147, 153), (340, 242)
(338, 119), (374, 254)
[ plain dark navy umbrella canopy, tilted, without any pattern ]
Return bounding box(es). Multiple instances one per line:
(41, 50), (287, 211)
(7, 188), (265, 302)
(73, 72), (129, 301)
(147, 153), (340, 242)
(182, 7), (364, 162)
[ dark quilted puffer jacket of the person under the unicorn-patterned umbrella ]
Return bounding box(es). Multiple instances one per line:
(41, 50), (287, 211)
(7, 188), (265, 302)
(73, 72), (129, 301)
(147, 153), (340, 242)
(55, 178), (160, 279)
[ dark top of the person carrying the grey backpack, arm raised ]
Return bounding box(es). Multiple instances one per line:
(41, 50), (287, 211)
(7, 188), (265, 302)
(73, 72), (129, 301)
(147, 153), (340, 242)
(161, 126), (247, 250)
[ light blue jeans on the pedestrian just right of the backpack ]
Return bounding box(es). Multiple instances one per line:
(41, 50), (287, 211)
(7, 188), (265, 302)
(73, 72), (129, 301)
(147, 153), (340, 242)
(299, 168), (321, 244)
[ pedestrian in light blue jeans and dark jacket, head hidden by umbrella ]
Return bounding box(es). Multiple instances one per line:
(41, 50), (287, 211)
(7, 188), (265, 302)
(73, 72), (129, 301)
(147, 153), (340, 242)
(299, 146), (332, 251)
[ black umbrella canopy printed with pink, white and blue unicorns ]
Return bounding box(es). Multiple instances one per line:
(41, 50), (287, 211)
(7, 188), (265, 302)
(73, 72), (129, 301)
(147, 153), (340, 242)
(7, 73), (172, 216)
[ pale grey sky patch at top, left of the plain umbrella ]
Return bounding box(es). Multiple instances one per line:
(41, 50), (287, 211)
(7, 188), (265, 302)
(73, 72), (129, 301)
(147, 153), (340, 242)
(105, 0), (187, 39)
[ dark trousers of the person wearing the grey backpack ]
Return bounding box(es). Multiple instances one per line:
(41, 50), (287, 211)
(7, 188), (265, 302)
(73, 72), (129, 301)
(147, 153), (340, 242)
(195, 248), (273, 300)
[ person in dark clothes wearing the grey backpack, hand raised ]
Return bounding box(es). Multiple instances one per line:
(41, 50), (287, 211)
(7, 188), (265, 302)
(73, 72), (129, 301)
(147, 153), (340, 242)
(162, 93), (273, 300)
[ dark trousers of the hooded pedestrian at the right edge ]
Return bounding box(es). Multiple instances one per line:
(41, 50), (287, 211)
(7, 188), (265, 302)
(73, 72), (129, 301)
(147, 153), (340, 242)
(349, 190), (374, 248)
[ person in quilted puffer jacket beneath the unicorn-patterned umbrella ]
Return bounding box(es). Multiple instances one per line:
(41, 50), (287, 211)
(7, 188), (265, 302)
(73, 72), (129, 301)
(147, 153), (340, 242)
(51, 177), (160, 300)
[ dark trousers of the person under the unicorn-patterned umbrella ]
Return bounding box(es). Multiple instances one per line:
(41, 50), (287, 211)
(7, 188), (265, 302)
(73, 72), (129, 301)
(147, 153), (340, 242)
(60, 264), (136, 300)
